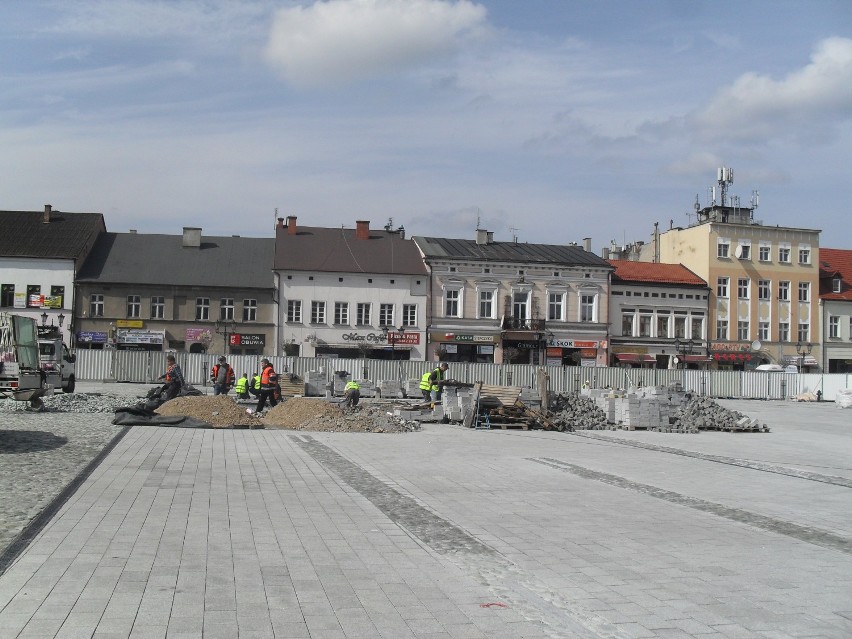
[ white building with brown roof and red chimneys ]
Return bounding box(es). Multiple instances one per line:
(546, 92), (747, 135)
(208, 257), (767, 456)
(274, 216), (428, 360)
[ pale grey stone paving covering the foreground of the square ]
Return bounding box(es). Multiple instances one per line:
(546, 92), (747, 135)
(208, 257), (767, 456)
(0, 382), (852, 639)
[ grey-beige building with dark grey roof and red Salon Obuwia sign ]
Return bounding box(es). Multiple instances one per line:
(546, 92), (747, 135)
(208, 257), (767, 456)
(75, 227), (276, 355)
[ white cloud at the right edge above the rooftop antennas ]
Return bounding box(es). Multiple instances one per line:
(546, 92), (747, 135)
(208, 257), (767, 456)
(690, 38), (852, 142)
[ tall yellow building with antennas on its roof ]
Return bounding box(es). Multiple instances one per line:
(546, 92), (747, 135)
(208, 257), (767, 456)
(641, 199), (820, 371)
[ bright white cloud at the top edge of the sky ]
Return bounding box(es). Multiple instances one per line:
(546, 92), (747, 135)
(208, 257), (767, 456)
(266, 0), (486, 87)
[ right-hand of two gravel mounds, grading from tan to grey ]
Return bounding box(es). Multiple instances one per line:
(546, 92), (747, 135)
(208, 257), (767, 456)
(263, 397), (419, 433)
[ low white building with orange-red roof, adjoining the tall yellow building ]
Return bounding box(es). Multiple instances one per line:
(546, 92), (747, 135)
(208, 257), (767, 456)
(609, 260), (713, 368)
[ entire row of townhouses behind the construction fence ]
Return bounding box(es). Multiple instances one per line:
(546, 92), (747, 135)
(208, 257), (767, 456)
(5, 198), (852, 372)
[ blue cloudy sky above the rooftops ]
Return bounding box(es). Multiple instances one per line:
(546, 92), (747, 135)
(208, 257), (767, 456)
(0, 0), (852, 252)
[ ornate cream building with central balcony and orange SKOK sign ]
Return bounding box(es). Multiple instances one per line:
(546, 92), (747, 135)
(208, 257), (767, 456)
(414, 229), (613, 366)
